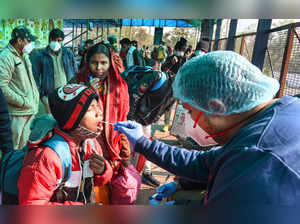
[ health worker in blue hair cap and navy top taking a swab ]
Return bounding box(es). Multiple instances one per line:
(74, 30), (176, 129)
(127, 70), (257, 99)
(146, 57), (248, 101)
(115, 51), (300, 206)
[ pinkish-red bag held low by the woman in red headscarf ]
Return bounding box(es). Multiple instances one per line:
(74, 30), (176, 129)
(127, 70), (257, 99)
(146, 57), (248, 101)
(111, 165), (141, 205)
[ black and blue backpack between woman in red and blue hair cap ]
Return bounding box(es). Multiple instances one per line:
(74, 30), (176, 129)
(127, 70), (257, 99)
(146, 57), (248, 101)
(121, 66), (175, 126)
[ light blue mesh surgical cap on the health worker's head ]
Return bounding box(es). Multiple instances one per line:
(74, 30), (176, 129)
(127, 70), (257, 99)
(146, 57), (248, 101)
(172, 51), (279, 115)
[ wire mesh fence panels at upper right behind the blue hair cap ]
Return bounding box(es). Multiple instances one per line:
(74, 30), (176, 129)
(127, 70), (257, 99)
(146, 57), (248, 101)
(212, 23), (300, 96)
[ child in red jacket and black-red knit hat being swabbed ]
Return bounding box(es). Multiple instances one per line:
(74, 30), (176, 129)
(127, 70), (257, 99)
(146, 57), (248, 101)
(18, 84), (113, 205)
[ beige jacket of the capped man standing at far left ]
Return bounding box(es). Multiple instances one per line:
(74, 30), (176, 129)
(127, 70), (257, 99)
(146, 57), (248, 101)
(0, 44), (39, 116)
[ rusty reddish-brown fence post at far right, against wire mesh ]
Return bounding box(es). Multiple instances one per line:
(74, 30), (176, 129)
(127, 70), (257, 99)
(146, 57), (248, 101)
(276, 25), (295, 97)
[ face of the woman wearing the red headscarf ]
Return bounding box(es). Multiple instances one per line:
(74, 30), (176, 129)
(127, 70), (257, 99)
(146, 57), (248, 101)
(89, 53), (110, 79)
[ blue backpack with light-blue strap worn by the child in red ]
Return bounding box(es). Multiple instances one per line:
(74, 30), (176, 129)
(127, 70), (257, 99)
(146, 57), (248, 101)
(0, 115), (72, 204)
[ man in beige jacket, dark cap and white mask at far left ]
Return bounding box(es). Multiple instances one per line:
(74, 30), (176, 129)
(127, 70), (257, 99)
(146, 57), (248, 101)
(0, 26), (39, 149)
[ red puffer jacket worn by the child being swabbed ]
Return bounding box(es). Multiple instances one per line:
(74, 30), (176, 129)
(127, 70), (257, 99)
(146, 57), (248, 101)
(18, 129), (113, 205)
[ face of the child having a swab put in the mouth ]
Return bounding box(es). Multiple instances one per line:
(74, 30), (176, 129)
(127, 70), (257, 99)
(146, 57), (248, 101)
(80, 99), (103, 132)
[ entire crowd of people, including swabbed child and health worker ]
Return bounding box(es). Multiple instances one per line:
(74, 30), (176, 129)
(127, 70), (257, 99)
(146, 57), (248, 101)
(0, 26), (300, 206)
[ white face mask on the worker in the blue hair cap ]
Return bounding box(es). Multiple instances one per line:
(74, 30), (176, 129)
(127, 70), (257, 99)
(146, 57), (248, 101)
(185, 113), (218, 147)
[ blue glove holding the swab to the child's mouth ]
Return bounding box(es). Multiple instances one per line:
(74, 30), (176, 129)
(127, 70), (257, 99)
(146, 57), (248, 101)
(114, 121), (144, 149)
